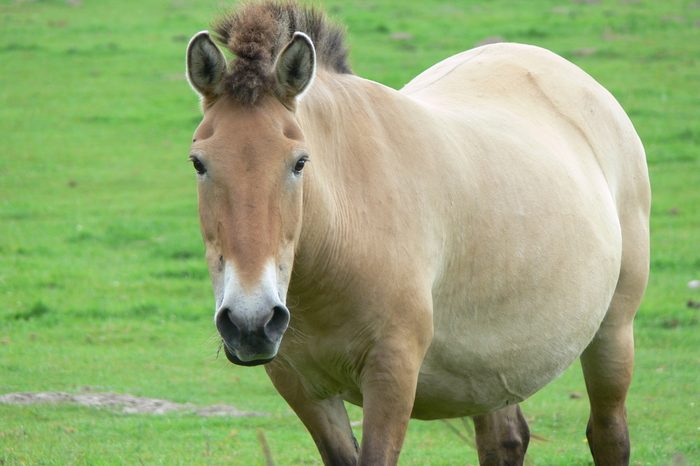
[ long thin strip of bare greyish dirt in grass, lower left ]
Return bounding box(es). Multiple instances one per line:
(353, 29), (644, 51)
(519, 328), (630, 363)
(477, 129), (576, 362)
(0, 392), (267, 417)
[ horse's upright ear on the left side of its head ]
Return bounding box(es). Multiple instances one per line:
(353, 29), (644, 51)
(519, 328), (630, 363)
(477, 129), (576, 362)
(187, 31), (226, 98)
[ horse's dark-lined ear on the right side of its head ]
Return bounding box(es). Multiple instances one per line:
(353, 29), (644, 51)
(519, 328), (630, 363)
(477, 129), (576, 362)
(275, 32), (316, 106)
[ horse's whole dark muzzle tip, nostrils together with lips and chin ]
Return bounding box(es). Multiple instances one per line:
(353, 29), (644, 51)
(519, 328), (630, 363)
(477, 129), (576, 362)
(216, 306), (290, 366)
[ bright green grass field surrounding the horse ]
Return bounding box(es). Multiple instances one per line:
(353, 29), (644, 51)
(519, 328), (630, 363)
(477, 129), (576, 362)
(0, 0), (700, 465)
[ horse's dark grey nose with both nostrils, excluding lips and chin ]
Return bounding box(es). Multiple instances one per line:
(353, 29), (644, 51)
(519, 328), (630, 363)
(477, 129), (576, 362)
(216, 306), (290, 352)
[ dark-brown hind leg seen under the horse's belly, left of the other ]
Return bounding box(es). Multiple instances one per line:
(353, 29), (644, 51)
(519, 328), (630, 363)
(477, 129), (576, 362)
(473, 405), (530, 466)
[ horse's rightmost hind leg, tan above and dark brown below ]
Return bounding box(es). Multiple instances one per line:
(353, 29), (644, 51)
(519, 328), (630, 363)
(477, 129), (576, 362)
(581, 224), (648, 466)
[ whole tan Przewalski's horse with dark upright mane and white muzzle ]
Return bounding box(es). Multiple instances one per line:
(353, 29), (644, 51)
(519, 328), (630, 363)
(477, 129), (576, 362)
(187, 3), (650, 465)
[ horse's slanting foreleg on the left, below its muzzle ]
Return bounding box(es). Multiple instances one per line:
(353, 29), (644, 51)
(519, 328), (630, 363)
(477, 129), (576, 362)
(267, 365), (359, 466)
